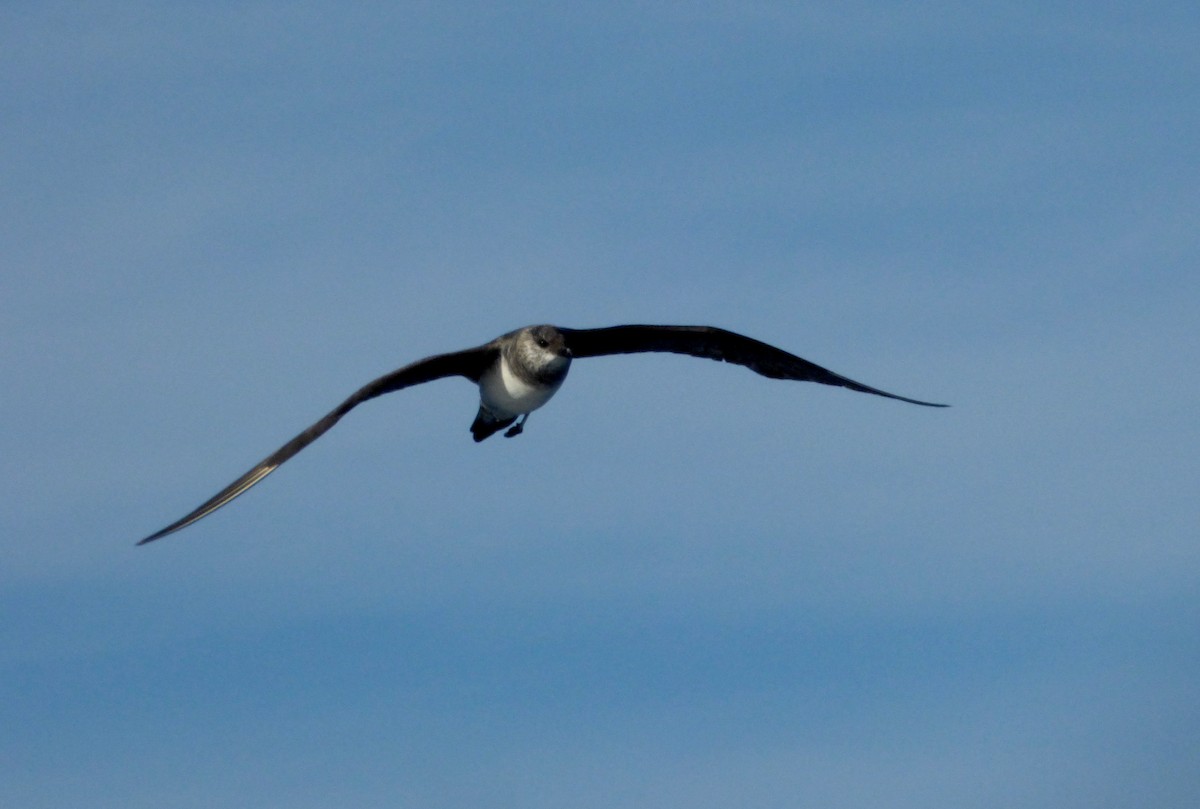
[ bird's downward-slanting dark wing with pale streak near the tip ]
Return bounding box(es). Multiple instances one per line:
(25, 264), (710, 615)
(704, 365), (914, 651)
(138, 343), (496, 545)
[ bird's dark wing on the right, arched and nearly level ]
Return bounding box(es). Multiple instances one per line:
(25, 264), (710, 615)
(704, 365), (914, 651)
(559, 325), (948, 407)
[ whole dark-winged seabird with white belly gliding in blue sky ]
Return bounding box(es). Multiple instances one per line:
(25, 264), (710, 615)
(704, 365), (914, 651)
(138, 325), (947, 545)
